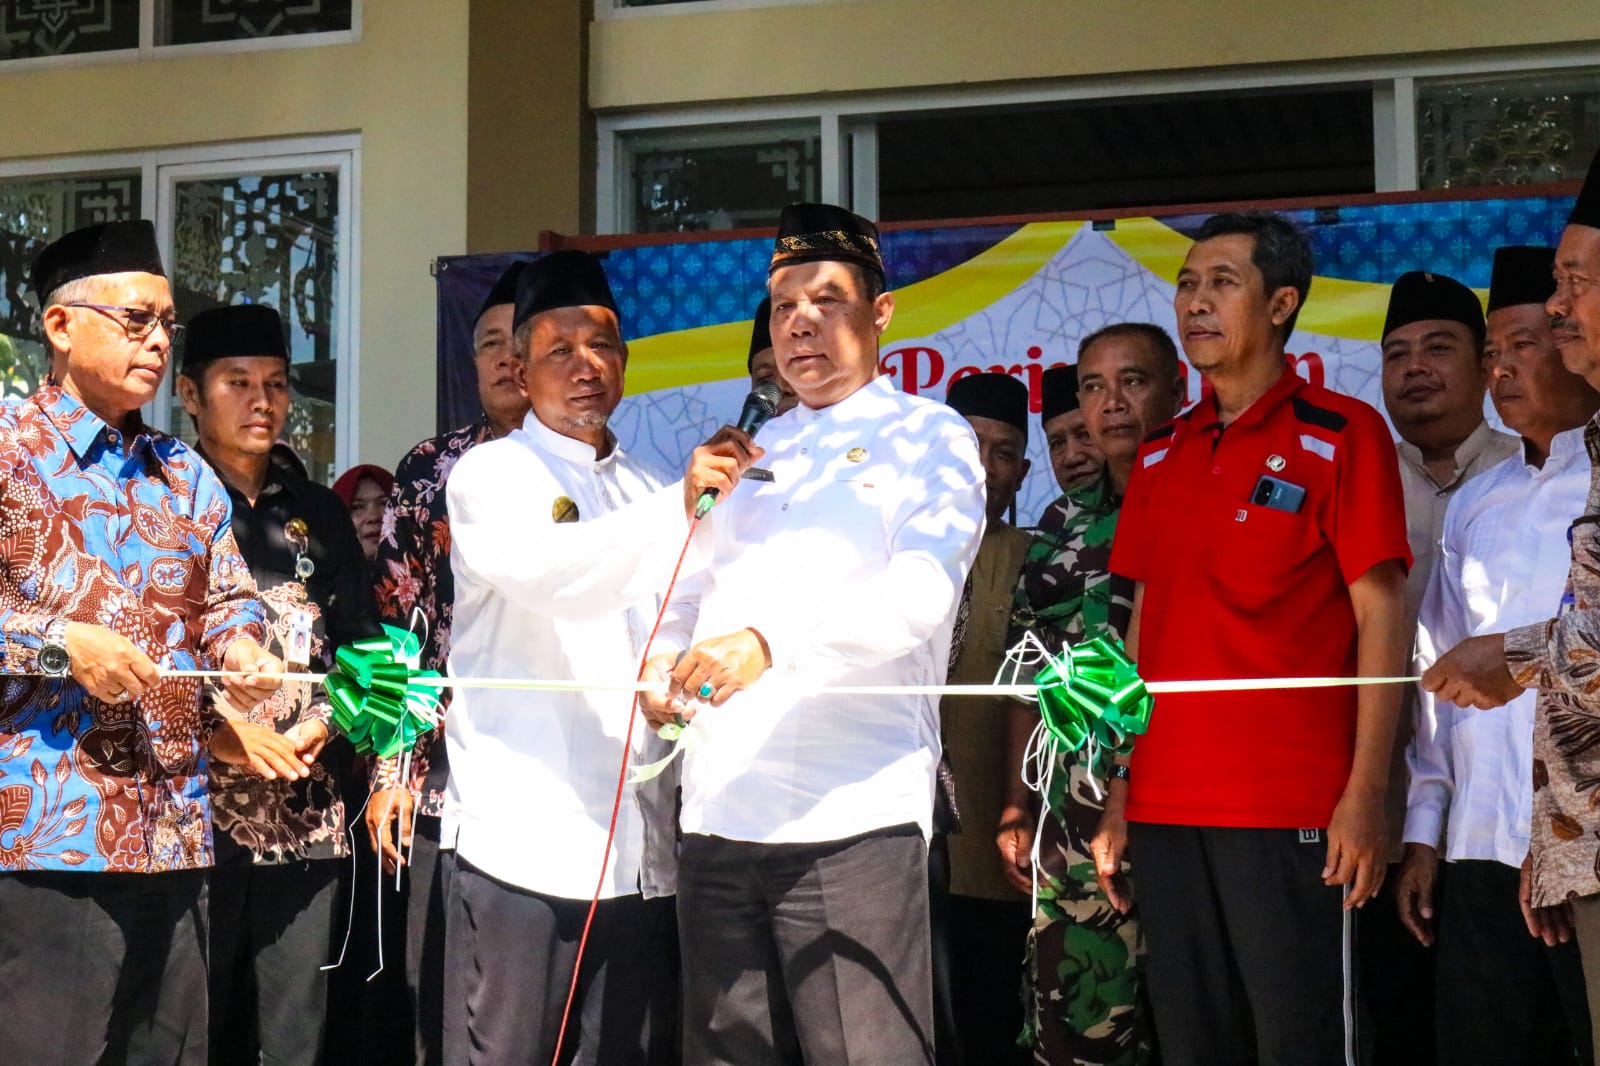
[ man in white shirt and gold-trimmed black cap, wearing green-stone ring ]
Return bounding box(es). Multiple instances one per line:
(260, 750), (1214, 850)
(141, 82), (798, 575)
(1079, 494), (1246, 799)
(650, 203), (984, 1066)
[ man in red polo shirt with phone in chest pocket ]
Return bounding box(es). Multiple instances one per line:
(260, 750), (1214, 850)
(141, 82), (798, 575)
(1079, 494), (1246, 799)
(1096, 213), (1411, 1066)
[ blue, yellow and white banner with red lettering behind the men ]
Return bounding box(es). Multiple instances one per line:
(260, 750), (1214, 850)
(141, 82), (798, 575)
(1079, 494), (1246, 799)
(438, 197), (1571, 525)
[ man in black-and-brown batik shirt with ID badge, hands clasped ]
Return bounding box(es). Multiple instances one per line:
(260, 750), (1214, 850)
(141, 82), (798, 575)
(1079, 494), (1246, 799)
(178, 304), (378, 1063)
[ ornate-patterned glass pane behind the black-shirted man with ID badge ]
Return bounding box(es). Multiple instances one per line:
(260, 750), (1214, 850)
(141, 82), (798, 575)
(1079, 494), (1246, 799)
(170, 170), (342, 483)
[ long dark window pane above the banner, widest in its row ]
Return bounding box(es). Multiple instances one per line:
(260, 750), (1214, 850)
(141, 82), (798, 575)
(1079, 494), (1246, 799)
(878, 86), (1373, 222)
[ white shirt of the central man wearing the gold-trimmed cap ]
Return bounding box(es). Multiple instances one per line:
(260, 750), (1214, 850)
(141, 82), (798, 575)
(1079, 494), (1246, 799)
(662, 378), (998, 844)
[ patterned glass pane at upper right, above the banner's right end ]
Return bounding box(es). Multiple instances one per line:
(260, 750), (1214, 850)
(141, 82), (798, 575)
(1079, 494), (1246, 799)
(1416, 70), (1600, 189)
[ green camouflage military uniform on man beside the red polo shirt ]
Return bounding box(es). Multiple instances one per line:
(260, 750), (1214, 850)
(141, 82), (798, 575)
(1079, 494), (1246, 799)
(1011, 474), (1154, 1066)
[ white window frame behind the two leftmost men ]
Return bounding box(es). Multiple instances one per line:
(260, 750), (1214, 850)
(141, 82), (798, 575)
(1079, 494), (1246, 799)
(0, 134), (362, 471)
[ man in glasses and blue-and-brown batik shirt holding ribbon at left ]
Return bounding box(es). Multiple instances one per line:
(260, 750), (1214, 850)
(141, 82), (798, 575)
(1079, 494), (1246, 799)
(0, 221), (282, 1066)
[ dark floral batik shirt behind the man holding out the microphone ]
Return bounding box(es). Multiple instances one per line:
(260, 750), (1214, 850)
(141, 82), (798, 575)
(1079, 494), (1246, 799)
(374, 418), (494, 818)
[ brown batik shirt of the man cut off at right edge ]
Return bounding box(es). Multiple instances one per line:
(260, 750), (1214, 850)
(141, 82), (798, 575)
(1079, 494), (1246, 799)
(1506, 416), (1600, 908)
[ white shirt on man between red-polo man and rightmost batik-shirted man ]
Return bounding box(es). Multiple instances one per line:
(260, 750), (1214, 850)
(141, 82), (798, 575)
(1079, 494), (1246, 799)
(1405, 429), (1589, 866)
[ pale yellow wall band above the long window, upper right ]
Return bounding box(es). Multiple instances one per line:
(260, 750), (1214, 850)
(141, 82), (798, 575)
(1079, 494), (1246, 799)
(589, 0), (1600, 110)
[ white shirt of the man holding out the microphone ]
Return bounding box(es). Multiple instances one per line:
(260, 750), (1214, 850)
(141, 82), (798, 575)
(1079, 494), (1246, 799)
(445, 413), (688, 900)
